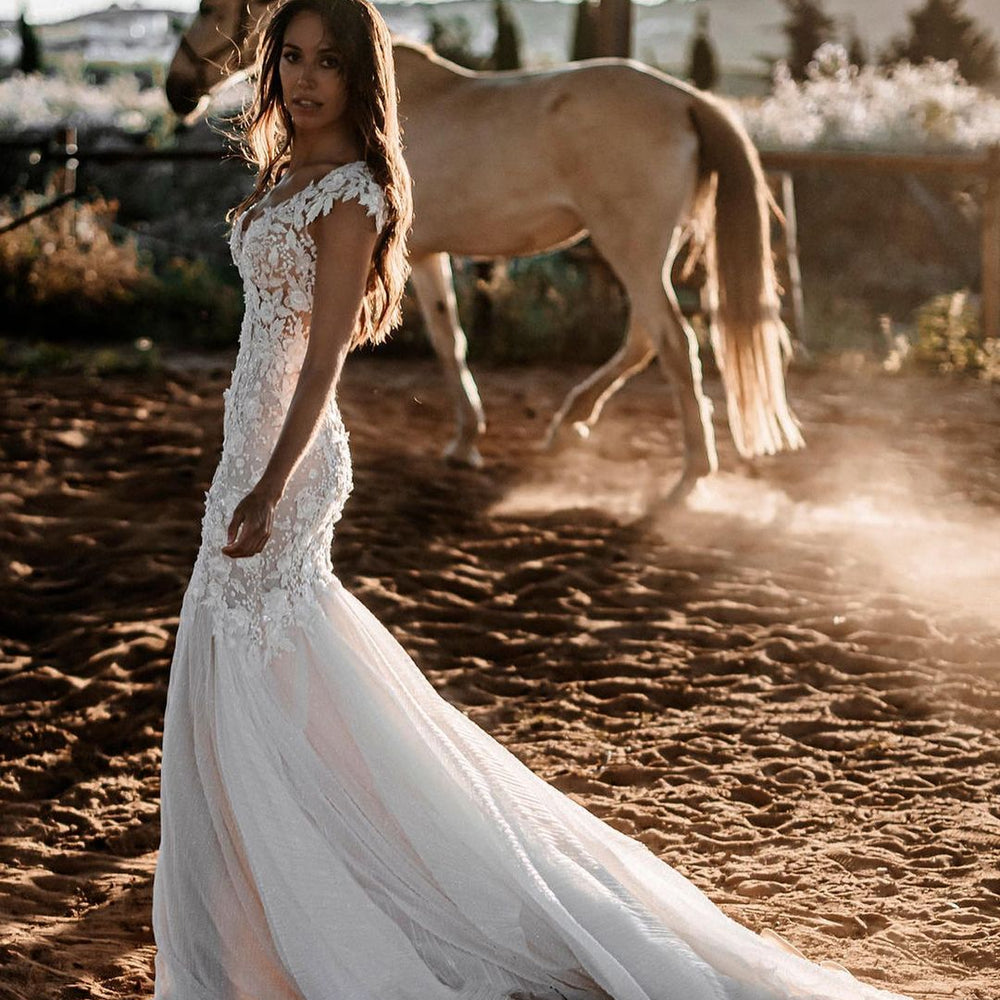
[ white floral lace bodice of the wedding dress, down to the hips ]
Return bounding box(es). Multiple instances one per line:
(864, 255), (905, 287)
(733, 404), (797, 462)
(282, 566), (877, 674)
(185, 161), (385, 662)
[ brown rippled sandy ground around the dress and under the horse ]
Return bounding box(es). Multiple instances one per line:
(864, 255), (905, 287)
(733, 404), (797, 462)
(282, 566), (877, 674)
(0, 358), (1000, 1000)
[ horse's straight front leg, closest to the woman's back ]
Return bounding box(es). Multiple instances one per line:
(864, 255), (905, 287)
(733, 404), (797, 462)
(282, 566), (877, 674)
(411, 253), (486, 468)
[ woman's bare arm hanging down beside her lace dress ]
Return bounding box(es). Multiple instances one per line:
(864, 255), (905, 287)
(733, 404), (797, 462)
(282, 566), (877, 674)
(222, 199), (378, 559)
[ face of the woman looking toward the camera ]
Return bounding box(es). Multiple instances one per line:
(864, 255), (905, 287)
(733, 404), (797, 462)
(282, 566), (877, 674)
(278, 11), (347, 132)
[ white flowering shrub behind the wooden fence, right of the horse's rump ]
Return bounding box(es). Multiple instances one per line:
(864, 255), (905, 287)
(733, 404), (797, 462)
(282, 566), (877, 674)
(738, 43), (1000, 153)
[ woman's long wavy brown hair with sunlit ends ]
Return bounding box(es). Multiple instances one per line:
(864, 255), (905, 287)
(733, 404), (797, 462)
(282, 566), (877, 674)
(226, 0), (413, 348)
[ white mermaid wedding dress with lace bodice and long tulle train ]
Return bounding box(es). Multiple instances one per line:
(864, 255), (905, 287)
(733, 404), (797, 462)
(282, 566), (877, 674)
(153, 162), (916, 1000)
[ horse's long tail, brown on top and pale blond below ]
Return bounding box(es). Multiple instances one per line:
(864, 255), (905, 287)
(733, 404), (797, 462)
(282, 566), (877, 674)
(690, 94), (805, 457)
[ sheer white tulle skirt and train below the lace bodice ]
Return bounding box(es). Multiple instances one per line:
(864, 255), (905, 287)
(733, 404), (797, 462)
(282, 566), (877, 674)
(156, 583), (916, 1000)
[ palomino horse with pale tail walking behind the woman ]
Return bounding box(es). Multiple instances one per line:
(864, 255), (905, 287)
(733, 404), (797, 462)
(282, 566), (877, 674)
(166, 0), (803, 498)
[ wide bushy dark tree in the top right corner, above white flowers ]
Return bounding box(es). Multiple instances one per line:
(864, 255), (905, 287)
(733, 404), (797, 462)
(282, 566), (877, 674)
(886, 0), (998, 83)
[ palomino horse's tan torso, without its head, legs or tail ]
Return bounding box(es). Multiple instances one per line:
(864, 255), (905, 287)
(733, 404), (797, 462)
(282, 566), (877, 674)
(397, 49), (698, 256)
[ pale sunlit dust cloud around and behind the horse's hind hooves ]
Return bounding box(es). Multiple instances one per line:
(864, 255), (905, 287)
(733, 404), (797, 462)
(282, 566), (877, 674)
(493, 372), (1000, 625)
